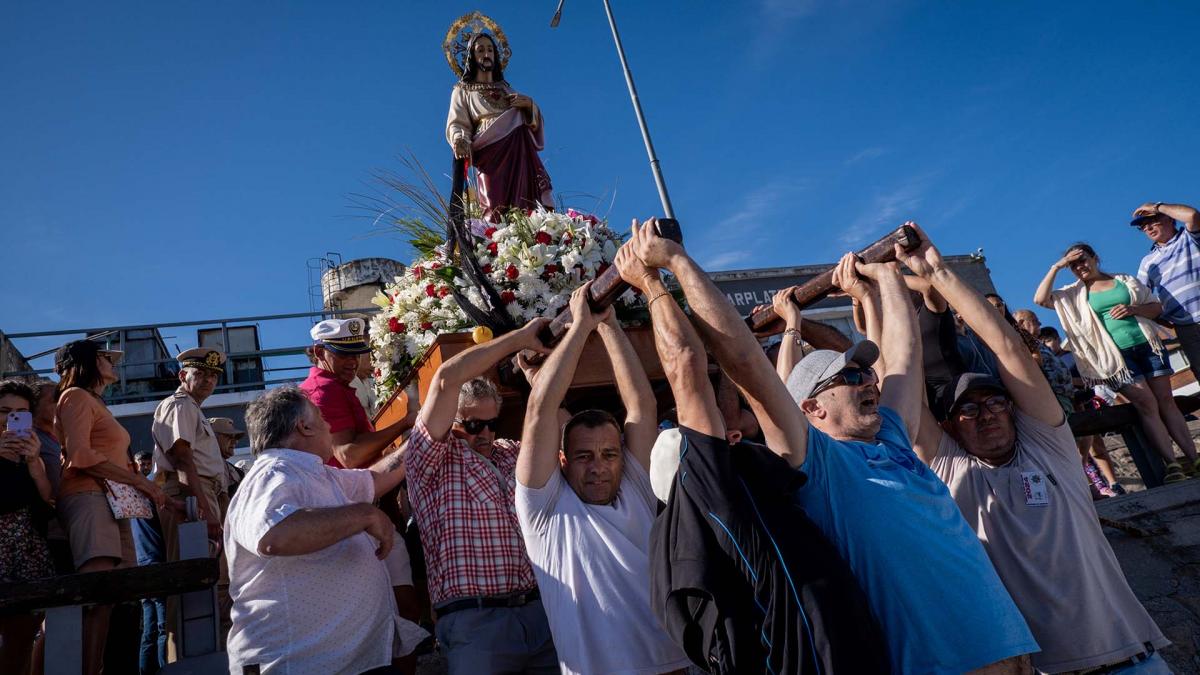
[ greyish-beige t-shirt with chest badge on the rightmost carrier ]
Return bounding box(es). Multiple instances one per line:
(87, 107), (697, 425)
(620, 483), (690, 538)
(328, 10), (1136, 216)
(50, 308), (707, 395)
(929, 412), (1170, 673)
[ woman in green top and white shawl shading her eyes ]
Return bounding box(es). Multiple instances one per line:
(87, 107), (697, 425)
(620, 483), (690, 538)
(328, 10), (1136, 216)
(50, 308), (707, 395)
(1033, 243), (1200, 483)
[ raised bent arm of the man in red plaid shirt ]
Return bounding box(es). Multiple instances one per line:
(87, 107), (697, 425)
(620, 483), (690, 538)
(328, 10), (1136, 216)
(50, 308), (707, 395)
(418, 317), (550, 441)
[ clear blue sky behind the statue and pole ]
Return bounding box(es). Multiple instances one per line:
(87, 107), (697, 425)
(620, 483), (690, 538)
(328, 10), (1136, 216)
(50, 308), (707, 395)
(0, 0), (1200, 331)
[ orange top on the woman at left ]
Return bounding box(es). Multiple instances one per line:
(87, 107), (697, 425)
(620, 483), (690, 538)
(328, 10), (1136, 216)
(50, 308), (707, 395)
(54, 387), (133, 497)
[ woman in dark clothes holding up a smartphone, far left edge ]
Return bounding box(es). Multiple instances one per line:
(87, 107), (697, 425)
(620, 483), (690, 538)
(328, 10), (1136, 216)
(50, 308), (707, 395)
(0, 380), (54, 673)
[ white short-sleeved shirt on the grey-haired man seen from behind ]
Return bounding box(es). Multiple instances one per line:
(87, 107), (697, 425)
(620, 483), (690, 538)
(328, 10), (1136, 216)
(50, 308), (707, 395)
(224, 449), (424, 675)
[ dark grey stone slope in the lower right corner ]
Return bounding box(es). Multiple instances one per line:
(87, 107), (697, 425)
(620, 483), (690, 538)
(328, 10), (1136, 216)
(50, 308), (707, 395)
(1096, 479), (1200, 674)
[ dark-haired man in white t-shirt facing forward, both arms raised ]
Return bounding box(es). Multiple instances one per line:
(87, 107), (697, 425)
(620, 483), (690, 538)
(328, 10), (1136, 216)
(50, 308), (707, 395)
(516, 285), (688, 675)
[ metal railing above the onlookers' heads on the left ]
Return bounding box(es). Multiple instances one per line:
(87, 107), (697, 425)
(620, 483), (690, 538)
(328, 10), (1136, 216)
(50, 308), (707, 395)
(0, 307), (379, 404)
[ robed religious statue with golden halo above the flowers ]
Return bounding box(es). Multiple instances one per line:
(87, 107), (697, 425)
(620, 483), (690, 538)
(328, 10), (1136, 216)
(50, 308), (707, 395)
(443, 12), (554, 222)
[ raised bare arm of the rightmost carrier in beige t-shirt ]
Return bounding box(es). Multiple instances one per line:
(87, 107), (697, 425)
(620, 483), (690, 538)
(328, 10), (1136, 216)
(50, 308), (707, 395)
(896, 220), (1064, 426)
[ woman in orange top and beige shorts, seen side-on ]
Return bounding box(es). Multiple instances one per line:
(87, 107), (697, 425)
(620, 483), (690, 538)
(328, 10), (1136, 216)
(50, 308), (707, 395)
(54, 340), (166, 675)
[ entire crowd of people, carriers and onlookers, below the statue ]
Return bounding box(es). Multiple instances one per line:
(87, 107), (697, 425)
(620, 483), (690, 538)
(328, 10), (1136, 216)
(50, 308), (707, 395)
(0, 196), (1200, 675)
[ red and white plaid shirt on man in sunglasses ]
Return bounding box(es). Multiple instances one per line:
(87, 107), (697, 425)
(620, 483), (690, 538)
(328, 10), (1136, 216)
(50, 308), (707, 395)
(404, 420), (538, 605)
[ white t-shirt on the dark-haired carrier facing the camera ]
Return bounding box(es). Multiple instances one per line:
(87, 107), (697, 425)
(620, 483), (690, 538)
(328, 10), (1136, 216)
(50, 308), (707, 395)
(516, 452), (690, 675)
